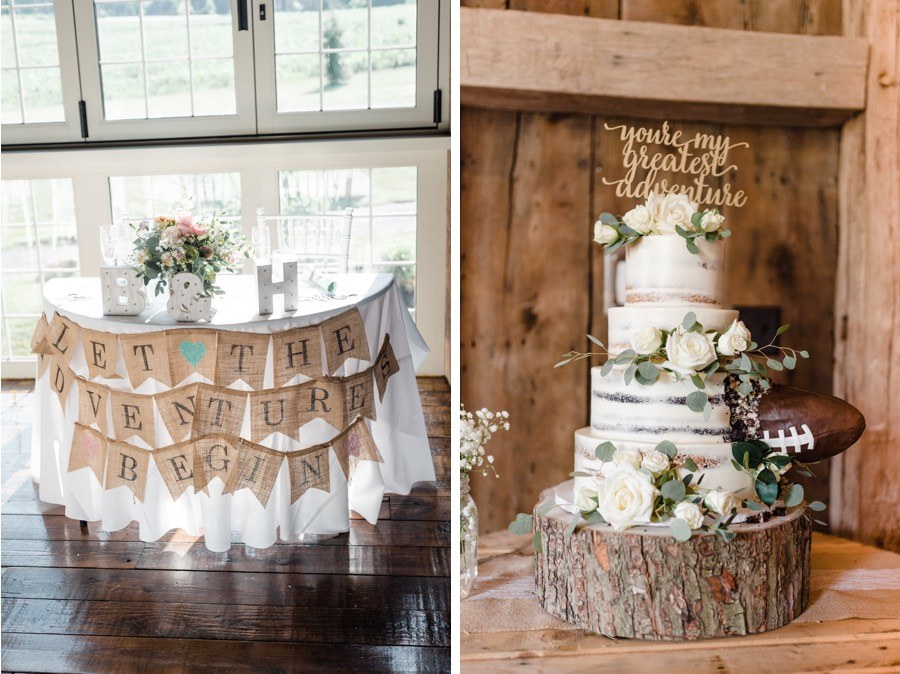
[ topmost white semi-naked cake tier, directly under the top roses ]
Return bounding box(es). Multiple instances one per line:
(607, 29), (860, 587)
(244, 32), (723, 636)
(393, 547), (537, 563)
(625, 234), (725, 307)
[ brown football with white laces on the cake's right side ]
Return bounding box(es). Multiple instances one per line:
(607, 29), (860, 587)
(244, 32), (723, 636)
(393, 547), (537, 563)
(759, 385), (866, 463)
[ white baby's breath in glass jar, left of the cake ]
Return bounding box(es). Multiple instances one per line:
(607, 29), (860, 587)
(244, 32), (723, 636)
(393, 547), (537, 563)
(459, 407), (509, 599)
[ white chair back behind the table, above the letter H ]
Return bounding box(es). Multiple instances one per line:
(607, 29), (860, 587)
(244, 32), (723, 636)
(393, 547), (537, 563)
(256, 208), (353, 274)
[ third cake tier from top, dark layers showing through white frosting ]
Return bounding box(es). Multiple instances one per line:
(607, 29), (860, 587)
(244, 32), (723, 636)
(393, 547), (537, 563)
(591, 367), (731, 442)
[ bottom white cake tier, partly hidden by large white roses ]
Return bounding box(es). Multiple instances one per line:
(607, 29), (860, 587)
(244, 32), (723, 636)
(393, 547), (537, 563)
(575, 427), (753, 494)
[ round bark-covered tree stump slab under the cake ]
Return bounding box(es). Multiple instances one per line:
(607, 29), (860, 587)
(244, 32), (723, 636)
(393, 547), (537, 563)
(534, 481), (812, 640)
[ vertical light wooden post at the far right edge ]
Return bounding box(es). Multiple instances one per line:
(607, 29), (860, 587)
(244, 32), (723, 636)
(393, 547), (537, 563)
(829, 0), (900, 551)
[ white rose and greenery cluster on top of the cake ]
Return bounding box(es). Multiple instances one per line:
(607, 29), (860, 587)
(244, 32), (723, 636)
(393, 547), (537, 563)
(594, 192), (731, 254)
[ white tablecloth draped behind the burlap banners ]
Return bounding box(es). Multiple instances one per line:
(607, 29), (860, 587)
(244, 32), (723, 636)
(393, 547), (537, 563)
(32, 274), (434, 551)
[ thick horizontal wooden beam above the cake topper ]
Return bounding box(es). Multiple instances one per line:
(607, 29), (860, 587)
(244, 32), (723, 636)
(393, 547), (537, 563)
(460, 7), (867, 126)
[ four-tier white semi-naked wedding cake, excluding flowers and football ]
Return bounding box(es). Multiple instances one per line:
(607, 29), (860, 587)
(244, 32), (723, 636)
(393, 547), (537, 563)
(575, 234), (753, 495)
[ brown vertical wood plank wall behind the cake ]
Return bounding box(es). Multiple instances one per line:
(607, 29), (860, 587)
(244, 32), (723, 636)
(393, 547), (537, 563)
(460, 0), (841, 532)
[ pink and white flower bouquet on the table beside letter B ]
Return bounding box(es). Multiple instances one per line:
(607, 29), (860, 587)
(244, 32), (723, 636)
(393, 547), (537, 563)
(132, 207), (251, 296)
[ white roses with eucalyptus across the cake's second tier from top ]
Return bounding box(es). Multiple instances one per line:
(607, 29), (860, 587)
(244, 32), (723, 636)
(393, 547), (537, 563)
(555, 311), (809, 419)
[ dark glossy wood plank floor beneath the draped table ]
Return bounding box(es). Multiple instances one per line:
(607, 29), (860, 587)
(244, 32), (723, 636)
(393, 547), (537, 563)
(0, 378), (450, 673)
